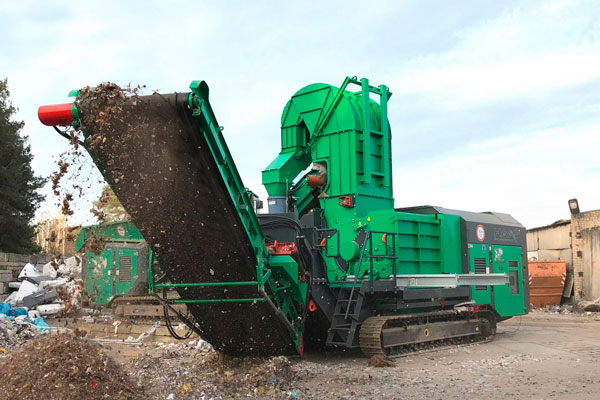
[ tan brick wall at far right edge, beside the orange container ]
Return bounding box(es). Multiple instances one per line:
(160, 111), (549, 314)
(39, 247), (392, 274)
(571, 210), (600, 300)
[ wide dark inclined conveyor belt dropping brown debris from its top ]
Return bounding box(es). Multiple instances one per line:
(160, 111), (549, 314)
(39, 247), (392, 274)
(77, 93), (295, 355)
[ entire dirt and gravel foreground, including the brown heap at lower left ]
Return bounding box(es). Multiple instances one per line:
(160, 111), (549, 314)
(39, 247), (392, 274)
(0, 311), (600, 400)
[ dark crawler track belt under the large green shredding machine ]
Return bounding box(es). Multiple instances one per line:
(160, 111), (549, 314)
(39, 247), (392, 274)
(359, 310), (491, 358)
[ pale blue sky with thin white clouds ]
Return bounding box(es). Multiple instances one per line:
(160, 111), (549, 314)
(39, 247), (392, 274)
(0, 0), (600, 228)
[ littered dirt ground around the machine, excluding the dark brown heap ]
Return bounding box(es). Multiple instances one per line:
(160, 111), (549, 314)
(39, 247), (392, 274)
(98, 311), (600, 400)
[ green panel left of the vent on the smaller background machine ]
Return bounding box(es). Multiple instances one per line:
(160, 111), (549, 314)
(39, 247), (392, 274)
(85, 248), (114, 305)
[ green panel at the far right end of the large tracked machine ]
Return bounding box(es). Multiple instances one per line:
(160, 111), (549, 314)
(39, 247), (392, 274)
(492, 246), (527, 317)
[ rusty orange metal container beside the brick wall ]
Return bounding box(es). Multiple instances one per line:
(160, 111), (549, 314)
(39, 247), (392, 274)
(529, 260), (567, 308)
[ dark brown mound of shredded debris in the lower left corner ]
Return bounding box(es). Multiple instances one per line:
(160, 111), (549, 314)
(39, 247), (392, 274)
(0, 334), (148, 400)
